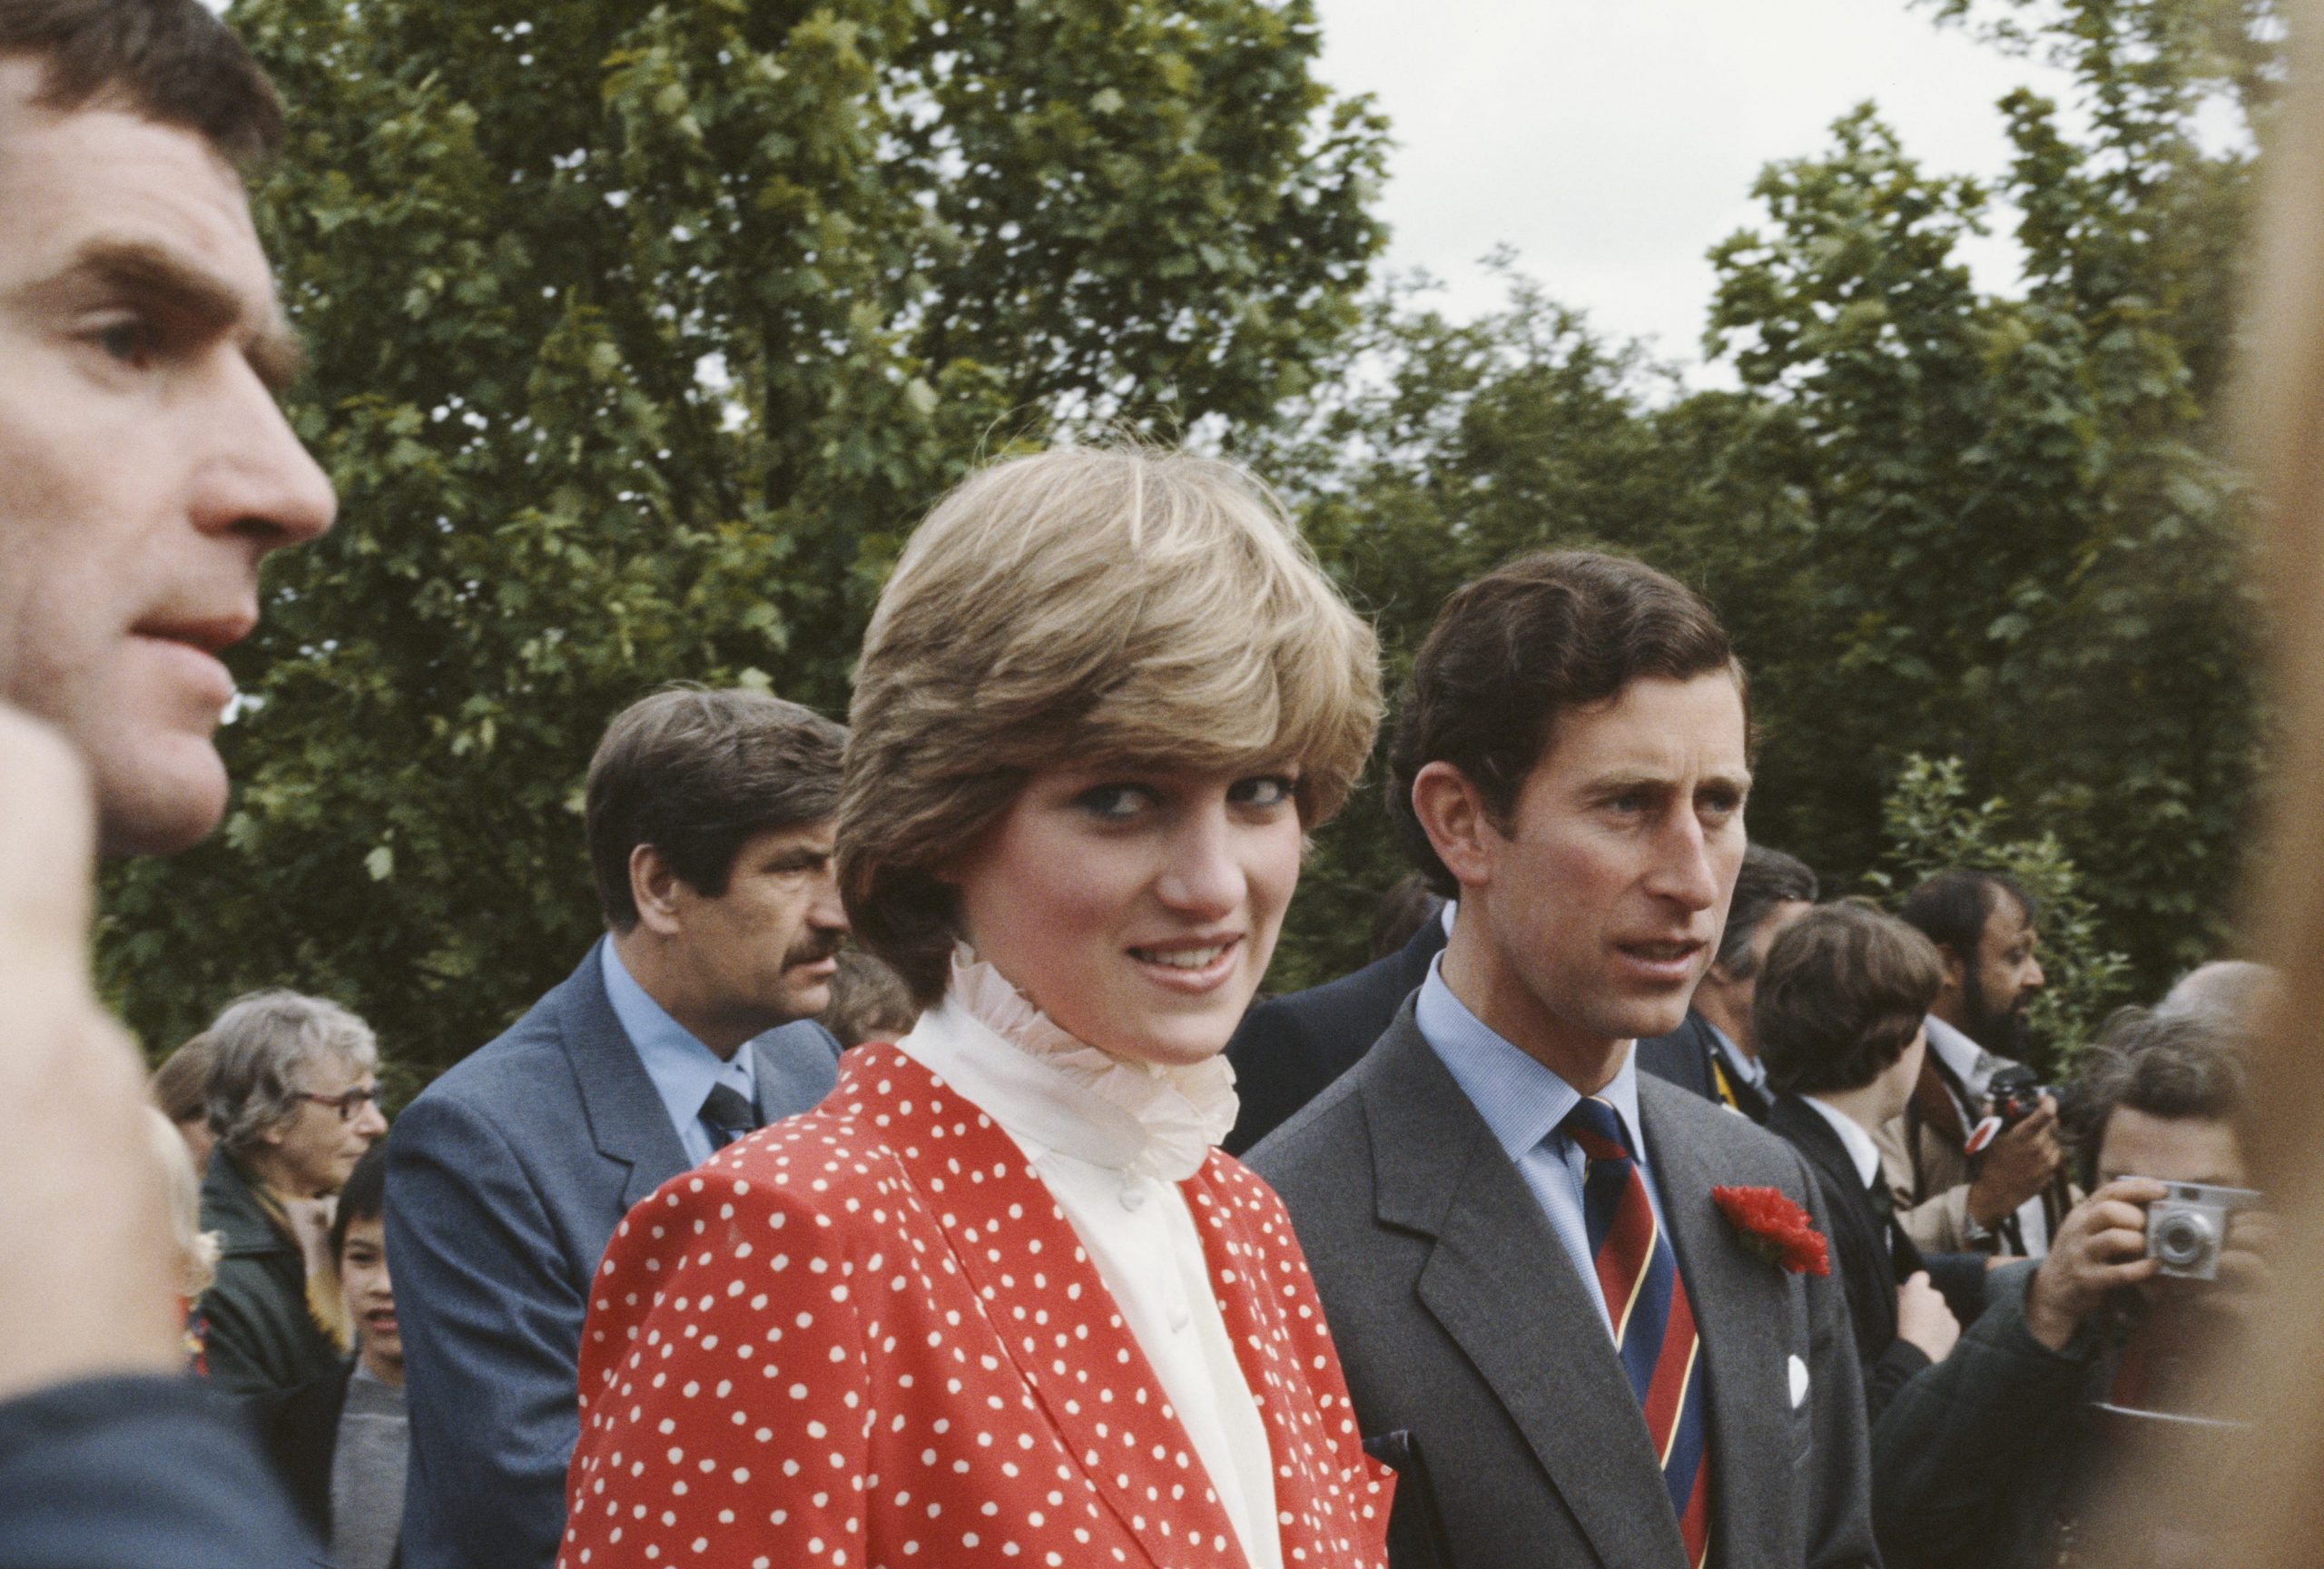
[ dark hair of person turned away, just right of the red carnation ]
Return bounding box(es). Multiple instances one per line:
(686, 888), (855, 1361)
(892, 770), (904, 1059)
(1750, 902), (1945, 1095)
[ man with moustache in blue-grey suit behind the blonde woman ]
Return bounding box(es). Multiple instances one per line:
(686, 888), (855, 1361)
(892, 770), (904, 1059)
(386, 690), (846, 1569)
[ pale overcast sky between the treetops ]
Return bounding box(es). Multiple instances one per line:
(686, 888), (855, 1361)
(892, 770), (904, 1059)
(1315, 0), (2071, 379)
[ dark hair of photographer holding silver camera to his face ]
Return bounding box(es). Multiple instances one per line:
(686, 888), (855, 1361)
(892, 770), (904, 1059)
(2059, 1009), (2250, 1190)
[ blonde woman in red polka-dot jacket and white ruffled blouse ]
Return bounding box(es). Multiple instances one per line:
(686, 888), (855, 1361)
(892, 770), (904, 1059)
(560, 451), (1390, 1569)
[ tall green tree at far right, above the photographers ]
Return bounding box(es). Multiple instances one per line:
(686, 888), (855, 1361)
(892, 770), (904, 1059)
(1710, 0), (2263, 981)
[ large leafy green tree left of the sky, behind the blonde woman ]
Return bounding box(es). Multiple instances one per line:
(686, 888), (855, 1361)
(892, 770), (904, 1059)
(103, 0), (1385, 1071)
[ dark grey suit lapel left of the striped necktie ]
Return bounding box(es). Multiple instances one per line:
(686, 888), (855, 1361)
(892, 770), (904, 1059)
(1362, 1018), (1718, 1564)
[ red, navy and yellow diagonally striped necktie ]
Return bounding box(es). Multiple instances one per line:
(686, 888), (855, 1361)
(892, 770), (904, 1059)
(1560, 1095), (1710, 1569)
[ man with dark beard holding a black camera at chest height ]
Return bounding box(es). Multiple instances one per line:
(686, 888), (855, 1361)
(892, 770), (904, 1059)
(1880, 867), (2068, 1258)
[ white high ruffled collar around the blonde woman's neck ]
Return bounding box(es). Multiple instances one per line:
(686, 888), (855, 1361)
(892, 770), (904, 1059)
(900, 948), (1236, 1183)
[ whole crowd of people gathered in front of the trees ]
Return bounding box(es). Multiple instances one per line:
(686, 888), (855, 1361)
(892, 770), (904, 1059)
(0, 0), (2314, 1569)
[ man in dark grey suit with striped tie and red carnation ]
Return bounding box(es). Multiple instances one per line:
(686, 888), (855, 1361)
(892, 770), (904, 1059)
(1250, 553), (1877, 1569)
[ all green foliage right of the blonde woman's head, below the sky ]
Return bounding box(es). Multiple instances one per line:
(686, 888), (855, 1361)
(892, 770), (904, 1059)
(1278, 0), (2273, 1009)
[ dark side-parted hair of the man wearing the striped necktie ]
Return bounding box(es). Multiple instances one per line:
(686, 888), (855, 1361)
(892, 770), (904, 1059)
(1387, 551), (1750, 897)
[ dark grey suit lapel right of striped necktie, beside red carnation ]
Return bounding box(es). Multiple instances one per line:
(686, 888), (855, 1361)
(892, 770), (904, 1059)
(1639, 1081), (1813, 1562)
